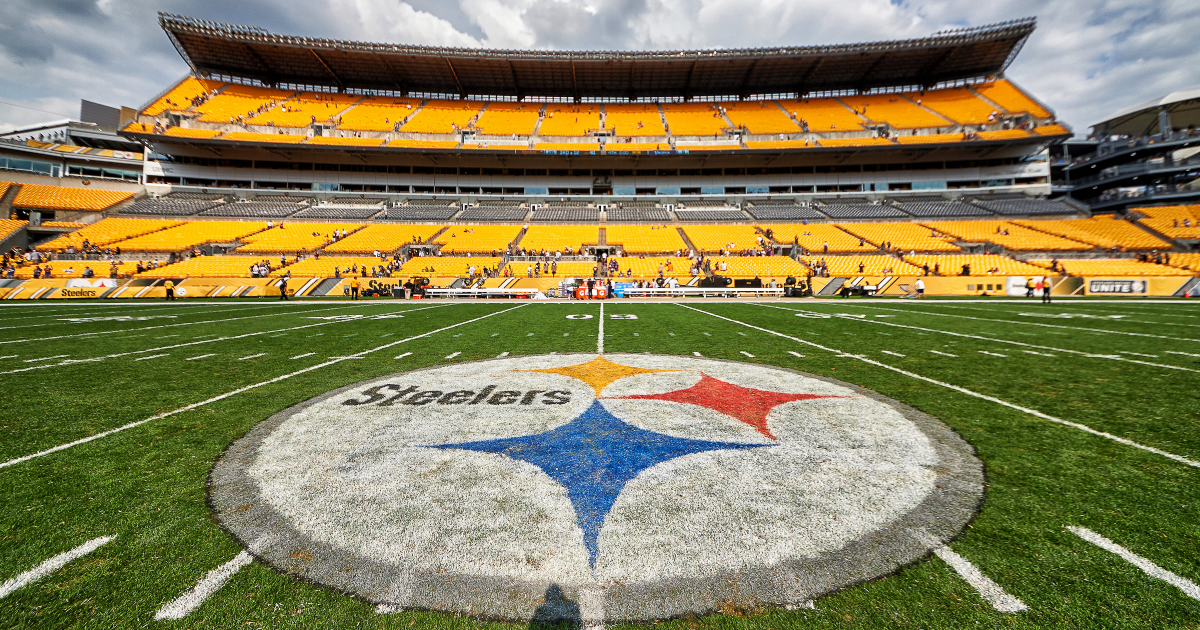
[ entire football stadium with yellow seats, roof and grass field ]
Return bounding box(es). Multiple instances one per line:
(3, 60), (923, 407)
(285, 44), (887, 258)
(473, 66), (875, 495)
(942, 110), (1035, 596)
(0, 13), (1200, 630)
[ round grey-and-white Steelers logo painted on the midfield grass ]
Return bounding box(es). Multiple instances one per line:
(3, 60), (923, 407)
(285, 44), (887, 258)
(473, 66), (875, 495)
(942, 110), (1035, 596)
(210, 354), (983, 622)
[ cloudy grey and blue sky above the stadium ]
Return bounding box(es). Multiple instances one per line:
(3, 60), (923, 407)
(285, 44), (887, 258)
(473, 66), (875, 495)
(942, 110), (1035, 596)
(0, 0), (1200, 134)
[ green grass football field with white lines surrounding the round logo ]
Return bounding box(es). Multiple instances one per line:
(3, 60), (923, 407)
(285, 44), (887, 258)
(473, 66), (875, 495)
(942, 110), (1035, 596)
(0, 299), (1200, 629)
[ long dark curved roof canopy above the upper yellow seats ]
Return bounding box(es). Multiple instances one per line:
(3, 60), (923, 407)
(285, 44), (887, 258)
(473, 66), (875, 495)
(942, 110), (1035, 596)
(158, 13), (1037, 100)
